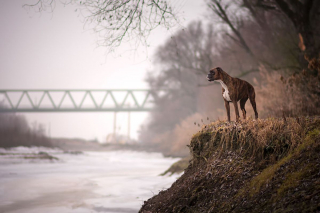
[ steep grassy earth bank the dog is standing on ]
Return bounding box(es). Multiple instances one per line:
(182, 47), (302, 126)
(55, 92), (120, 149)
(140, 117), (320, 212)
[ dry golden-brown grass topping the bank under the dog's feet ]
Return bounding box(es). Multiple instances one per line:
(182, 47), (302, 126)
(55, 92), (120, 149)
(190, 117), (320, 163)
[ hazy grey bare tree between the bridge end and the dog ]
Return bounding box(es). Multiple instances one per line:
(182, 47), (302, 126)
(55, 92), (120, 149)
(140, 22), (235, 151)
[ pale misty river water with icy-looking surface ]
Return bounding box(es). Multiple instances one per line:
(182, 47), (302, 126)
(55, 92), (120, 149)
(0, 147), (179, 213)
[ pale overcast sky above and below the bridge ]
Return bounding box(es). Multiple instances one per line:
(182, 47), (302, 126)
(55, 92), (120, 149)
(0, 0), (206, 142)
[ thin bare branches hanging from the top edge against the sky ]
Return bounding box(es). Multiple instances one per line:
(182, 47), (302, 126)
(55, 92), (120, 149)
(24, 0), (179, 51)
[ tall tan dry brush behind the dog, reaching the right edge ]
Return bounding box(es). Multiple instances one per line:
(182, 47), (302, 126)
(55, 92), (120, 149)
(255, 55), (320, 118)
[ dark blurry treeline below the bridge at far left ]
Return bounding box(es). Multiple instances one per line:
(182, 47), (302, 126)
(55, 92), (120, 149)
(0, 103), (52, 148)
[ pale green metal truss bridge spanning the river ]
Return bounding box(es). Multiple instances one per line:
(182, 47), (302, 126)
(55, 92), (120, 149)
(0, 89), (160, 112)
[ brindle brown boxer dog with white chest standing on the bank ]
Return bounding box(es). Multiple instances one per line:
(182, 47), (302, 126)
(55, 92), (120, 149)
(207, 67), (258, 122)
